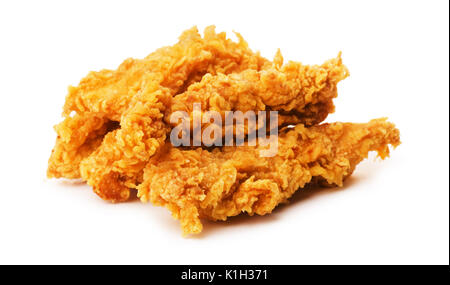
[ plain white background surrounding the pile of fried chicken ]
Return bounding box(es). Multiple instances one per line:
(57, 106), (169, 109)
(0, 0), (449, 264)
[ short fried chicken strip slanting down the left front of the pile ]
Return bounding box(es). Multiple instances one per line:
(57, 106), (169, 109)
(80, 84), (172, 202)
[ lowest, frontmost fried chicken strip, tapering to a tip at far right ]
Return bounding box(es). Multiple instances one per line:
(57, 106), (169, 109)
(138, 119), (400, 235)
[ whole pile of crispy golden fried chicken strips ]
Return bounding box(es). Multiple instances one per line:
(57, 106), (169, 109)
(47, 26), (400, 235)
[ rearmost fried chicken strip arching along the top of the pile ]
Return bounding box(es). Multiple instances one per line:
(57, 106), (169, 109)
(47, 26), (268, 178)
